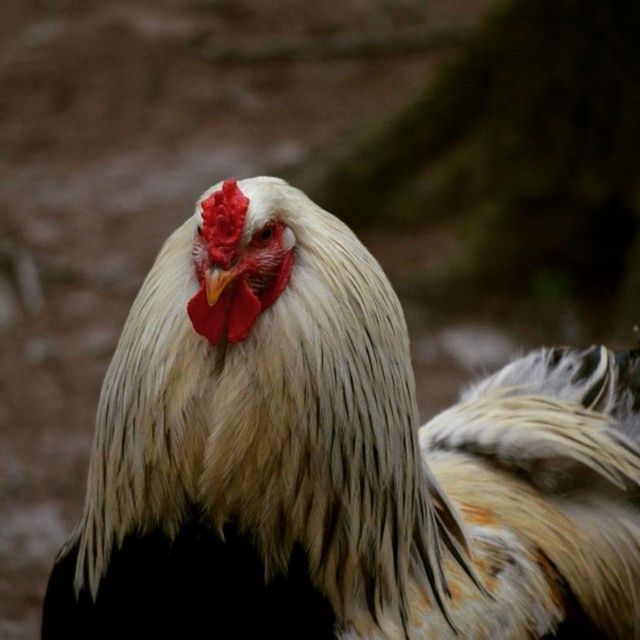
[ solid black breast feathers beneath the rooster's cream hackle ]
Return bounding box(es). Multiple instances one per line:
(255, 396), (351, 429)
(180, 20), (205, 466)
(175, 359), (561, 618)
(42, 515), (335, 640)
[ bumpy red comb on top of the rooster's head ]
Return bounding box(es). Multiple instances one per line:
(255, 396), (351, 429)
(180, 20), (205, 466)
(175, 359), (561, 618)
(201, 178), (249, 269)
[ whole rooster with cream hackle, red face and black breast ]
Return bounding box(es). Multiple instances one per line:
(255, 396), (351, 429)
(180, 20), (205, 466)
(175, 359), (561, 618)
(42, 177), (640, 640)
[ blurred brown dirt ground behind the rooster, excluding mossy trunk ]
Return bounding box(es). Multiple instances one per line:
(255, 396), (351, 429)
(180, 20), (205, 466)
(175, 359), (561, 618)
(0, 0), (532, 640)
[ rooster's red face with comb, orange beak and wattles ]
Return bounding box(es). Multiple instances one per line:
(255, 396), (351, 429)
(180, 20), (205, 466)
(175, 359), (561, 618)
(187, 180), (296, 344)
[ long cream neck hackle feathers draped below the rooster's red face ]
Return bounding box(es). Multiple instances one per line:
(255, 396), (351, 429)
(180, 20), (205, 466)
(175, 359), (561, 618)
(76, 179), (465, 624)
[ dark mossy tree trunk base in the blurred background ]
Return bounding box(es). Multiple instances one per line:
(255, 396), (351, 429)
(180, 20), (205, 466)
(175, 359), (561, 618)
(304, 0), (640, 318)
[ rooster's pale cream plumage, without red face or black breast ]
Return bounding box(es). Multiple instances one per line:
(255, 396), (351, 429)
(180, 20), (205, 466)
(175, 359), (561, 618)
(48, 178), (640, 640)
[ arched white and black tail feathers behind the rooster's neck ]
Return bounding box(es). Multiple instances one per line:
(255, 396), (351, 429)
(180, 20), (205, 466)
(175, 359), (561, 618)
(421, 346), (640, 490)
